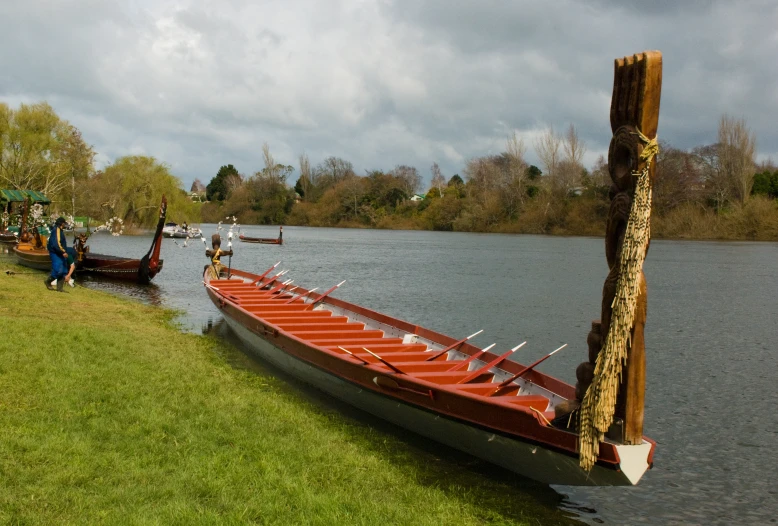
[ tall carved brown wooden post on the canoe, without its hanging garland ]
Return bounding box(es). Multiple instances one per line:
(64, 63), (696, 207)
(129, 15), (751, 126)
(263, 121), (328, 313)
(576, 51), (662, 450)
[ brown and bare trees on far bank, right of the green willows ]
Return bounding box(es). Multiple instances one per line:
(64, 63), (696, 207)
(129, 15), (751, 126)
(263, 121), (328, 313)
(203, 115), (778, 239)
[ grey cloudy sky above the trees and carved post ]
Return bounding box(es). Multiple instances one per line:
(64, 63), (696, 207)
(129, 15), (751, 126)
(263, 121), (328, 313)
(0, 0), (778, 189)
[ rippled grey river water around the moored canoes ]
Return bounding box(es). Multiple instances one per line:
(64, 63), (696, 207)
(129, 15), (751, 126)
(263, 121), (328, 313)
(9, 225), (778, 525)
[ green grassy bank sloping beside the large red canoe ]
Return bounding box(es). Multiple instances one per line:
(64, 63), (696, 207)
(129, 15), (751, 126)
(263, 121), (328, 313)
(0, 261), (569, 525)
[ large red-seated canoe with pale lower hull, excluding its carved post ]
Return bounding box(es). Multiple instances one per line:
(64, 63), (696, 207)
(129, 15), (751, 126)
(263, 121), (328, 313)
(204, 267), (654, 485)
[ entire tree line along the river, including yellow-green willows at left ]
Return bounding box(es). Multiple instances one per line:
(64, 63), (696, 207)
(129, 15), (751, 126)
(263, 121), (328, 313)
(0, 102), (778, 239)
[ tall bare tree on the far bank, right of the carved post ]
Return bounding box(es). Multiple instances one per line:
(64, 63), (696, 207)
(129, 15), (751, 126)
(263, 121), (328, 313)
(719, 114), (756, 203)
